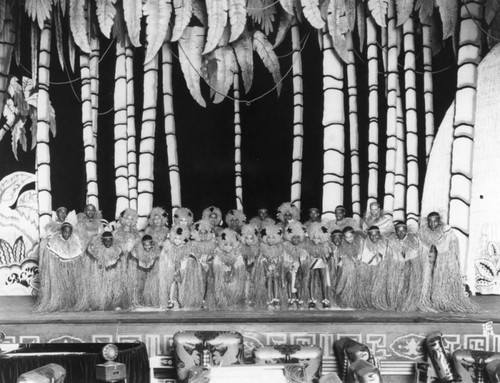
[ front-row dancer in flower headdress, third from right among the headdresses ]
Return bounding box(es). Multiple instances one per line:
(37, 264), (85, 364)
(256, 224), (286, 309)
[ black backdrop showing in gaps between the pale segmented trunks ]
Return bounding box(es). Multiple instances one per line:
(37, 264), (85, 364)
(0, 23), (456, 219)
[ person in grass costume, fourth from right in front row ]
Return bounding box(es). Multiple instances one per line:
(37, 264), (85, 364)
(337, 226), (365, 307)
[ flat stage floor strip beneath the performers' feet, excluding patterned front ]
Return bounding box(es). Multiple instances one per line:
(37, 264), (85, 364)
(0, 296), (500, 325)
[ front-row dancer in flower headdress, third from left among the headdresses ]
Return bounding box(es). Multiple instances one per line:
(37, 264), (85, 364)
(209, 229), (248, 309)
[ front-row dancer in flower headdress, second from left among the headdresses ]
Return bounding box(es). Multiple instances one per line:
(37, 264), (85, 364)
(189, 219), (217, 306)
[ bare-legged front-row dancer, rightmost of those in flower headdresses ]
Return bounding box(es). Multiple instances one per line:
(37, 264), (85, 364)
(307, 222), (331, 308)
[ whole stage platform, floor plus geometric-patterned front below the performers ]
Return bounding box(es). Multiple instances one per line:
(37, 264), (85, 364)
(0, 296), (500, 382)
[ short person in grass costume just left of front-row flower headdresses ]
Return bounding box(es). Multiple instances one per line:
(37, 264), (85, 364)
(128, 234), (161, 307)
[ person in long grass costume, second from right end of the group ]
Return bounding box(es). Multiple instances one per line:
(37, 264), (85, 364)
(387, 222), (427, 311)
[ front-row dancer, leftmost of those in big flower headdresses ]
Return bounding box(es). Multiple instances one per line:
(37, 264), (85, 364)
(159, 225), (194, 309)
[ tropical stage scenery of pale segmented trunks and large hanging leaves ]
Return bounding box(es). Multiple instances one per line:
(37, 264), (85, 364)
(0, 0), (500, 296)
